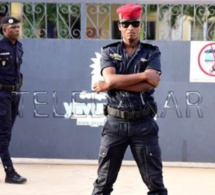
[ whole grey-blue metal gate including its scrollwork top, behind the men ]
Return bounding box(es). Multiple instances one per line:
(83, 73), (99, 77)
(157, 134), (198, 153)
(0, 0), (215, 162)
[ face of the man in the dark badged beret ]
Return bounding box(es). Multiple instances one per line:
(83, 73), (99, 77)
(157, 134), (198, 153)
(3, 24), (20, 41)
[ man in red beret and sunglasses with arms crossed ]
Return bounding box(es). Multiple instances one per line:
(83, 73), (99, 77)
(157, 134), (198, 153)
(92, 4), (167, 195)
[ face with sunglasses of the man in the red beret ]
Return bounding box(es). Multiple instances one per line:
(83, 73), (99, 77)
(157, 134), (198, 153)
(118, 21), (141, 40)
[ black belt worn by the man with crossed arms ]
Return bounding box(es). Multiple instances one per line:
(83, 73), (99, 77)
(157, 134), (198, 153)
(106, 106), (151, 120)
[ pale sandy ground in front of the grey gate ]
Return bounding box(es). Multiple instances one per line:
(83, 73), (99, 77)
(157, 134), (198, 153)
(0, 159), (215, 195)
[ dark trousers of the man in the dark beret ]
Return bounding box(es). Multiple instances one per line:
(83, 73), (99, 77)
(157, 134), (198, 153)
(0, 91), (20, 168)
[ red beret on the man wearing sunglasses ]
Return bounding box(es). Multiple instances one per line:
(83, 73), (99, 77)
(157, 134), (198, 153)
(116, 4), (142, 21)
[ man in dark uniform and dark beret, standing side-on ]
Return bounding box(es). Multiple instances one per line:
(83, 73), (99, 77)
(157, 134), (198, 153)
(0, 17), (27, 184)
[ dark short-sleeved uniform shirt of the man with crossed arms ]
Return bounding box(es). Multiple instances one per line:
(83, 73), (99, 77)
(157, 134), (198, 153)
(100, 42), (161, 111)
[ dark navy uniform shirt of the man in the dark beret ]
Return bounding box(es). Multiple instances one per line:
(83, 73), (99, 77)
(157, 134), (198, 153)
(0, 37), (23, 85)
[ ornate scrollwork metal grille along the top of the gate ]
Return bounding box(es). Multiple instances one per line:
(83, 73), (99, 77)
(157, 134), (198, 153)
(0, 0), (215, 41)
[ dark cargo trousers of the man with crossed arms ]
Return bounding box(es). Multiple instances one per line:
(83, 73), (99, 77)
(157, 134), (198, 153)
(92, 116), (167, 195)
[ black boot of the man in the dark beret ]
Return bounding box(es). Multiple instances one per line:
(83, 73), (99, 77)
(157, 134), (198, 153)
(5, 167), (27, 184)
